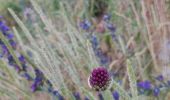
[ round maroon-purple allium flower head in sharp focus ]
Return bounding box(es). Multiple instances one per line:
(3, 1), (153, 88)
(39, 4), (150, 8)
(88, 67), (111, 91)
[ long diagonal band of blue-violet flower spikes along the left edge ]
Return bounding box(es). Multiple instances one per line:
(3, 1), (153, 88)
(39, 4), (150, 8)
(0, 16), (64, 97)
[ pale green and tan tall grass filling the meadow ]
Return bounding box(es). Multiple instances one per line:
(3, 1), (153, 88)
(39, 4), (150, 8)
(0, 0), (169, 100)
